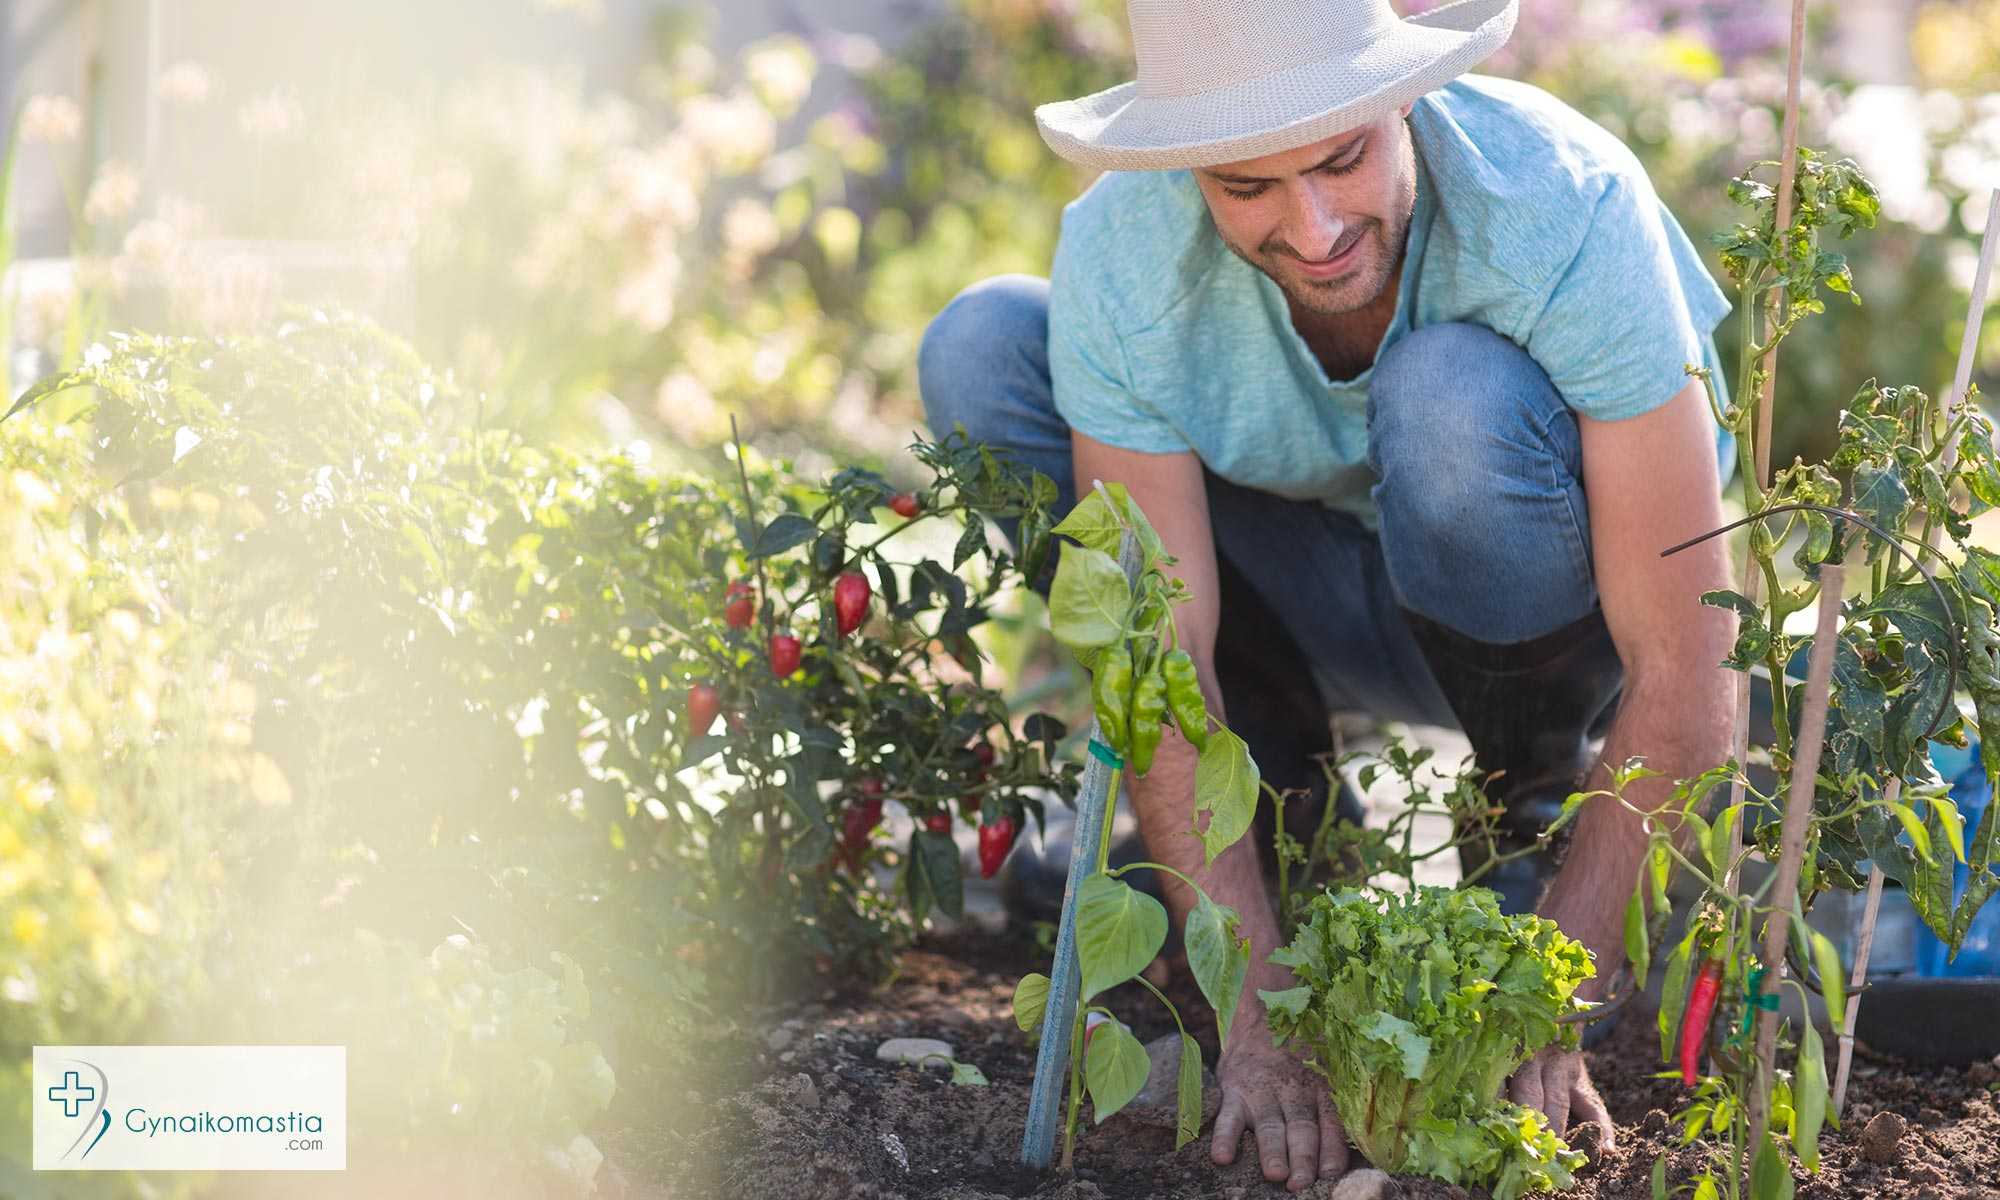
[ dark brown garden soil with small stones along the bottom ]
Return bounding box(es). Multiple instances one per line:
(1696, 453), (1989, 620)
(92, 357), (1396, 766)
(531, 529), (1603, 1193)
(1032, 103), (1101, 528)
(624, 932), (2000, 1200)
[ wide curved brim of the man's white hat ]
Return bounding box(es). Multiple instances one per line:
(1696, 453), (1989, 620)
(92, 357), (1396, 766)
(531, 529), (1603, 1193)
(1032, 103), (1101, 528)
(1034, 0), (1518, 170)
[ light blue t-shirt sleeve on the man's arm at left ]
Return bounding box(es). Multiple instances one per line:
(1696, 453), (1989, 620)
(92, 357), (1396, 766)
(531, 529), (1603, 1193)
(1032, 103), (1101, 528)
(1048, 231), (1190, 454)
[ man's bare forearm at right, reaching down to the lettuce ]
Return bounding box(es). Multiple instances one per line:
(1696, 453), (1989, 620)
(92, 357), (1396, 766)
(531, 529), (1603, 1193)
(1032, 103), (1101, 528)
(1540, 668), (1736, 998)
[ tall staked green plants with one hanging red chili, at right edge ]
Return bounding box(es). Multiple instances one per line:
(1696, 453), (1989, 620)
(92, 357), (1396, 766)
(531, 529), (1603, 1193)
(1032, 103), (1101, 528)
(1608, 148), (2000, 1200)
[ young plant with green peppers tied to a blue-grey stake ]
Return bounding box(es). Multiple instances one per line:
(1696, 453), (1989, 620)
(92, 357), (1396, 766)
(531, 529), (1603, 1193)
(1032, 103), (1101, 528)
(1014, 484), (1258, 1168)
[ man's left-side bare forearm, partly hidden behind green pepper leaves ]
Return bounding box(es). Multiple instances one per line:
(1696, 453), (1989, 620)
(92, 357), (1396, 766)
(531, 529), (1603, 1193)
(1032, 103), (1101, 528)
(1132, 728), (1292, 1042)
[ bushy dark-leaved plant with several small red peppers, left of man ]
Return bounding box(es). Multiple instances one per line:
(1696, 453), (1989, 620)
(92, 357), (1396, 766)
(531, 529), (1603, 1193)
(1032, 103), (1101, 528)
(668, 428), (1080, 992)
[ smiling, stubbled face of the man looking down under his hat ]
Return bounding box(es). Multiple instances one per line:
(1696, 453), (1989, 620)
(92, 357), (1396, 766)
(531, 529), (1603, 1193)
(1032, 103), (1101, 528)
(1194, 106), (1416, 316)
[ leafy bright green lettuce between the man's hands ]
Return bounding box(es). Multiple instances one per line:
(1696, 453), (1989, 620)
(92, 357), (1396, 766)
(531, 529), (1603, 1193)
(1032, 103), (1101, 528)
(1260, 888), (1594, 1200)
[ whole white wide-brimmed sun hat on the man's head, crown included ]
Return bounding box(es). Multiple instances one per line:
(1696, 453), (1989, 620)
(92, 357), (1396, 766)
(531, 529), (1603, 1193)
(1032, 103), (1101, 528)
(1034, 0), (1518, 170)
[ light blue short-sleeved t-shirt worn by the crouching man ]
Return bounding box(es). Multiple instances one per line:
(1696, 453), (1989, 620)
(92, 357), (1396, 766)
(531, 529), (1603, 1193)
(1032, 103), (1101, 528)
(1048, 76), (1734, 526)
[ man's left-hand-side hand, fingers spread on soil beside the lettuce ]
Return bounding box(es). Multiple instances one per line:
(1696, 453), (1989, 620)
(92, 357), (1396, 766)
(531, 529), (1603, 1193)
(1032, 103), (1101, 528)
(1210, 1012), (1348, 1192)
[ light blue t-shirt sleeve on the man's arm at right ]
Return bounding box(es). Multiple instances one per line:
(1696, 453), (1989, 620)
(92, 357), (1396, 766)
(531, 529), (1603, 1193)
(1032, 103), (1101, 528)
(1524, 176), (1730, 420)
